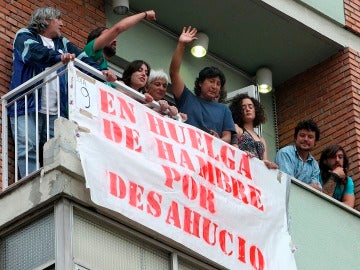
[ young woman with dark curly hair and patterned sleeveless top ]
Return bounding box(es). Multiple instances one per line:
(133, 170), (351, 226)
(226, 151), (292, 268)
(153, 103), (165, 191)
(229, 94), (277, 169)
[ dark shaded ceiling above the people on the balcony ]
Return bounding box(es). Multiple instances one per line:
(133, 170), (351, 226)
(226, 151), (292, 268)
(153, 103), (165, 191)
(130, 0), (342, 86)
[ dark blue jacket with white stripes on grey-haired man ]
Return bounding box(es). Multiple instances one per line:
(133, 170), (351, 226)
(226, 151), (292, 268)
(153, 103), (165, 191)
(8, 28), (101, 117)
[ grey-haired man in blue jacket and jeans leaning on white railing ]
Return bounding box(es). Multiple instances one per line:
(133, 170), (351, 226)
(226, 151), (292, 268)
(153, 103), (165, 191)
(8, 7), (116, 177)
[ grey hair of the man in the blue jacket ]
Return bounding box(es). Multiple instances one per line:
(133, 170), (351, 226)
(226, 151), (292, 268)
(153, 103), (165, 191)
(27, 7), (61, 33)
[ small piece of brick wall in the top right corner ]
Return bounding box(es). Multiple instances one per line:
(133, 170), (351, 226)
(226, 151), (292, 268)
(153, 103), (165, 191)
(344, 0), (360, 35)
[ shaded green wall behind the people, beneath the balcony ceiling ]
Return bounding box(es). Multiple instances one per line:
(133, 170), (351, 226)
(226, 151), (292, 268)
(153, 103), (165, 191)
(105, 5), (276, 160)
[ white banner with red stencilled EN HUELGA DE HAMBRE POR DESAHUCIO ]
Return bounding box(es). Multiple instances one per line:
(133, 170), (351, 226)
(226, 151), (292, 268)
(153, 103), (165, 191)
(70, 68), (296, 270)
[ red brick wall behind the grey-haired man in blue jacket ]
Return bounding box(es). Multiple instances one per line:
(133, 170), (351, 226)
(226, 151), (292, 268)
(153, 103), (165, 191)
(0, 0), (106, 190)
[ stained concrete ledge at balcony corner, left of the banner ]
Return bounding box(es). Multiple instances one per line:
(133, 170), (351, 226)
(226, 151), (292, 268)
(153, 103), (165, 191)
(0, 118), (91, 232)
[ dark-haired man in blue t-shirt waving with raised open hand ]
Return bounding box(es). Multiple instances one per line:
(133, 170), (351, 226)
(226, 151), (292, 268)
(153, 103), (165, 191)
(169, 26), (235, 143)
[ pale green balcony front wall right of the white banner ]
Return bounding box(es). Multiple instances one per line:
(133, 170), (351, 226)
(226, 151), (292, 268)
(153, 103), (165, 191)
(289, 181), (360, 270)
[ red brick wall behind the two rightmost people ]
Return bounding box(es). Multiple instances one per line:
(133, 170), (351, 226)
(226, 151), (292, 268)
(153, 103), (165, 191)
(275, 49), (360, 210)
